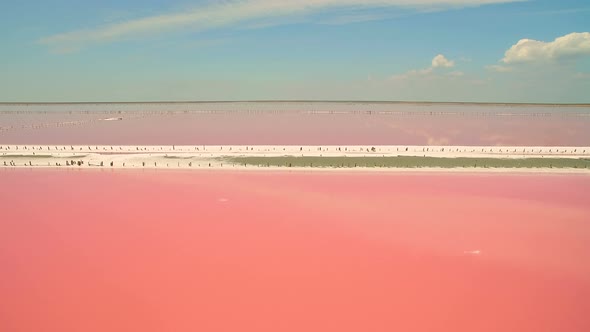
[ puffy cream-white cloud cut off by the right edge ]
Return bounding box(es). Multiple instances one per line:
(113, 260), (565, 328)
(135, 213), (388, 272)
(502, 32), (590, 64)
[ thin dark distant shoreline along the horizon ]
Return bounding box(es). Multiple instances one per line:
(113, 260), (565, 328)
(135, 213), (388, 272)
(0, 100), (590, 107)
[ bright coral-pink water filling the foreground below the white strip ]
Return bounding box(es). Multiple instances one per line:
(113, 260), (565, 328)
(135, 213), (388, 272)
(0, 170), (590, 332)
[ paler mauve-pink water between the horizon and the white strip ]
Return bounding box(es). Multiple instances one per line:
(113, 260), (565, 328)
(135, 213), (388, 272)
(0, 103), (590, 146)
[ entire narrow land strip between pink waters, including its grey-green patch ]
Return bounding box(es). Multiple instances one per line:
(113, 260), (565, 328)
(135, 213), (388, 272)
(0, 145), (590, 174)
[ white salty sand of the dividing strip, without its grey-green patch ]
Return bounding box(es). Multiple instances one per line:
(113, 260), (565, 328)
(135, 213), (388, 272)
(0, 145), (590, 174)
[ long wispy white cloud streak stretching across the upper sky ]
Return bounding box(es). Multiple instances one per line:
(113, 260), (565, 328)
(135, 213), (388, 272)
(39, 0), (523, 47)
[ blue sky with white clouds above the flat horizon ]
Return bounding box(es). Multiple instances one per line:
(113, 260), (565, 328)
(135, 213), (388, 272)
(0, 0), (590, 103)
